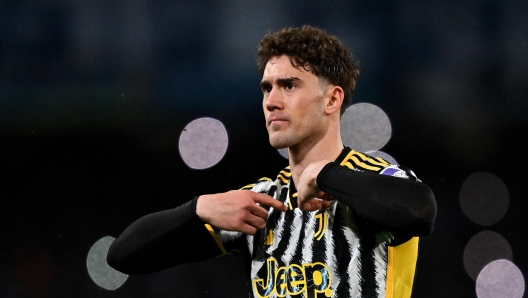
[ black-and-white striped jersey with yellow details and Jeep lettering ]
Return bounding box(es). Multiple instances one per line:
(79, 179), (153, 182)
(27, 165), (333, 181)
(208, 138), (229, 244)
(208, 148), (419, 298)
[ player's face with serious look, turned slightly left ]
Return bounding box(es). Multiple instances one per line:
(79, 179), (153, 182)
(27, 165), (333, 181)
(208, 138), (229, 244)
(260, 56), (326, 148)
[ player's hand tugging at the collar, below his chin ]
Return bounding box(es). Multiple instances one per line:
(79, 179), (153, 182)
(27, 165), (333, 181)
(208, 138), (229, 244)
(296, 160), (332, 211)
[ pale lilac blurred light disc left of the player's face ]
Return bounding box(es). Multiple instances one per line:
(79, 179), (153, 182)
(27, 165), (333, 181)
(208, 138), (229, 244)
(179, 117), (229, 170)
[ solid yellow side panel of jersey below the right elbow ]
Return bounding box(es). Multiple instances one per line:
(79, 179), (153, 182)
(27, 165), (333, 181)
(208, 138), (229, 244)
(385, 237), (418, 298)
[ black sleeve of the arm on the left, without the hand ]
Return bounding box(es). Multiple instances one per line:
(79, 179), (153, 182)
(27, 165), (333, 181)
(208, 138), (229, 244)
(107, 197), (221, 274)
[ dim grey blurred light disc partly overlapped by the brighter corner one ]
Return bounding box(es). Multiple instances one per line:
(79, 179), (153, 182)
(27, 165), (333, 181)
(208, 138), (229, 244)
(464, 231), (513, 280)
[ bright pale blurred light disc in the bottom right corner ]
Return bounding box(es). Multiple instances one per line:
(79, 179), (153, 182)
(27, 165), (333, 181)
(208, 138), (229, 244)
(476, 260), (525, 298)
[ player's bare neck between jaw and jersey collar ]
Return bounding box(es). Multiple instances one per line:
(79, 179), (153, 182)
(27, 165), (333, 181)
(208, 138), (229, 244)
(288, 123), (344, 189)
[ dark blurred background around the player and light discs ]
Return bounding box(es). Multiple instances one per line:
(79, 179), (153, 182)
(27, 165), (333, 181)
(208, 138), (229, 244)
(0, 0), (528, 298)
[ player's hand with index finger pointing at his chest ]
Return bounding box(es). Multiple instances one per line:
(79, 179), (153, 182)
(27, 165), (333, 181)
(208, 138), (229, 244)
(196, 190), (287, 235)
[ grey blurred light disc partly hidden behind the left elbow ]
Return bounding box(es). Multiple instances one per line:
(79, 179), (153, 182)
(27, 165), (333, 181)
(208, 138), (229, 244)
(86, 236), (128, 290)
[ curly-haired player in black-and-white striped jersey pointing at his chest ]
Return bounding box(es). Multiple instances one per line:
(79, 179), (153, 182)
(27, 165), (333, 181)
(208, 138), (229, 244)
(108, 26), (436, 298)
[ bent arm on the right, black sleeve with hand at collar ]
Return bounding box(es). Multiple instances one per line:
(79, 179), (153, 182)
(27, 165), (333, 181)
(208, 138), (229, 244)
(298, 161), (436, 237)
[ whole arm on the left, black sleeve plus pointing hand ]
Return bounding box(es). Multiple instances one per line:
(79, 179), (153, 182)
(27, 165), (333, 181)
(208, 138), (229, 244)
(107, 190), (286, 274)
